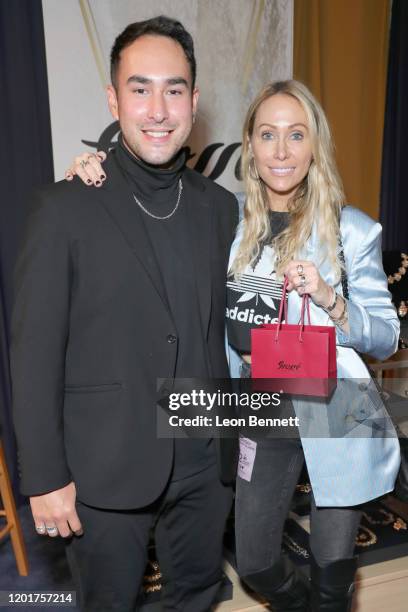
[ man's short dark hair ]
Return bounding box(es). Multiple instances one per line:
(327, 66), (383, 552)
(111, 15), (197, 87)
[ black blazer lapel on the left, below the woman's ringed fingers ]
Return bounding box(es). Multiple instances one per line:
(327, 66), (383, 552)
(99, 152), (170, 311)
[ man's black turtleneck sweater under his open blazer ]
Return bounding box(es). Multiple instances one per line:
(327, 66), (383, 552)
(116, 136), (215, 480)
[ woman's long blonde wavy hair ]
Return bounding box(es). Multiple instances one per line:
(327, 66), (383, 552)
(230, 80), (345, 280)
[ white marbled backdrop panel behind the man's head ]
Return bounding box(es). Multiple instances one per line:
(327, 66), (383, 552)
(43, 0), (293, 191)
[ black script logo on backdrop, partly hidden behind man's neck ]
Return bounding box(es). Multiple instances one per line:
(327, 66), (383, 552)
(81, 121), (242, 181)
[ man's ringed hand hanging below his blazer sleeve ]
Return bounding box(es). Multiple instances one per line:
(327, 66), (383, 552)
(30, 482), (83, 538)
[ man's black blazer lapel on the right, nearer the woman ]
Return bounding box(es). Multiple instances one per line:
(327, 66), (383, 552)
(183, 168), (212, 336)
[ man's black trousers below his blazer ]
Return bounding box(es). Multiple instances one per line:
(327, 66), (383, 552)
(67, 465), (232, 612)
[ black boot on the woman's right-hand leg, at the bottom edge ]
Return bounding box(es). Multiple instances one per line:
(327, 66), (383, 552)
(311, 557), (357, 612)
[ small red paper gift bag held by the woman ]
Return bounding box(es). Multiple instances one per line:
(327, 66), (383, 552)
(251, 279), (337, 397)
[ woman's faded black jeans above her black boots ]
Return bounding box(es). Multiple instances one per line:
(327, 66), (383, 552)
(235, 438), (361, 576)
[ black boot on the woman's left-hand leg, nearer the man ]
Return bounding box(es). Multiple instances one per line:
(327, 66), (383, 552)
(242, 557), (310, 612)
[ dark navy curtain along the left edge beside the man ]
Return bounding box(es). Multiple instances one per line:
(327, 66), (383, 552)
(0, 0), (54, 492)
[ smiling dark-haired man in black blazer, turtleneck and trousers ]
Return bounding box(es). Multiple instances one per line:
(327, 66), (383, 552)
(11, 17), (237, 612)
